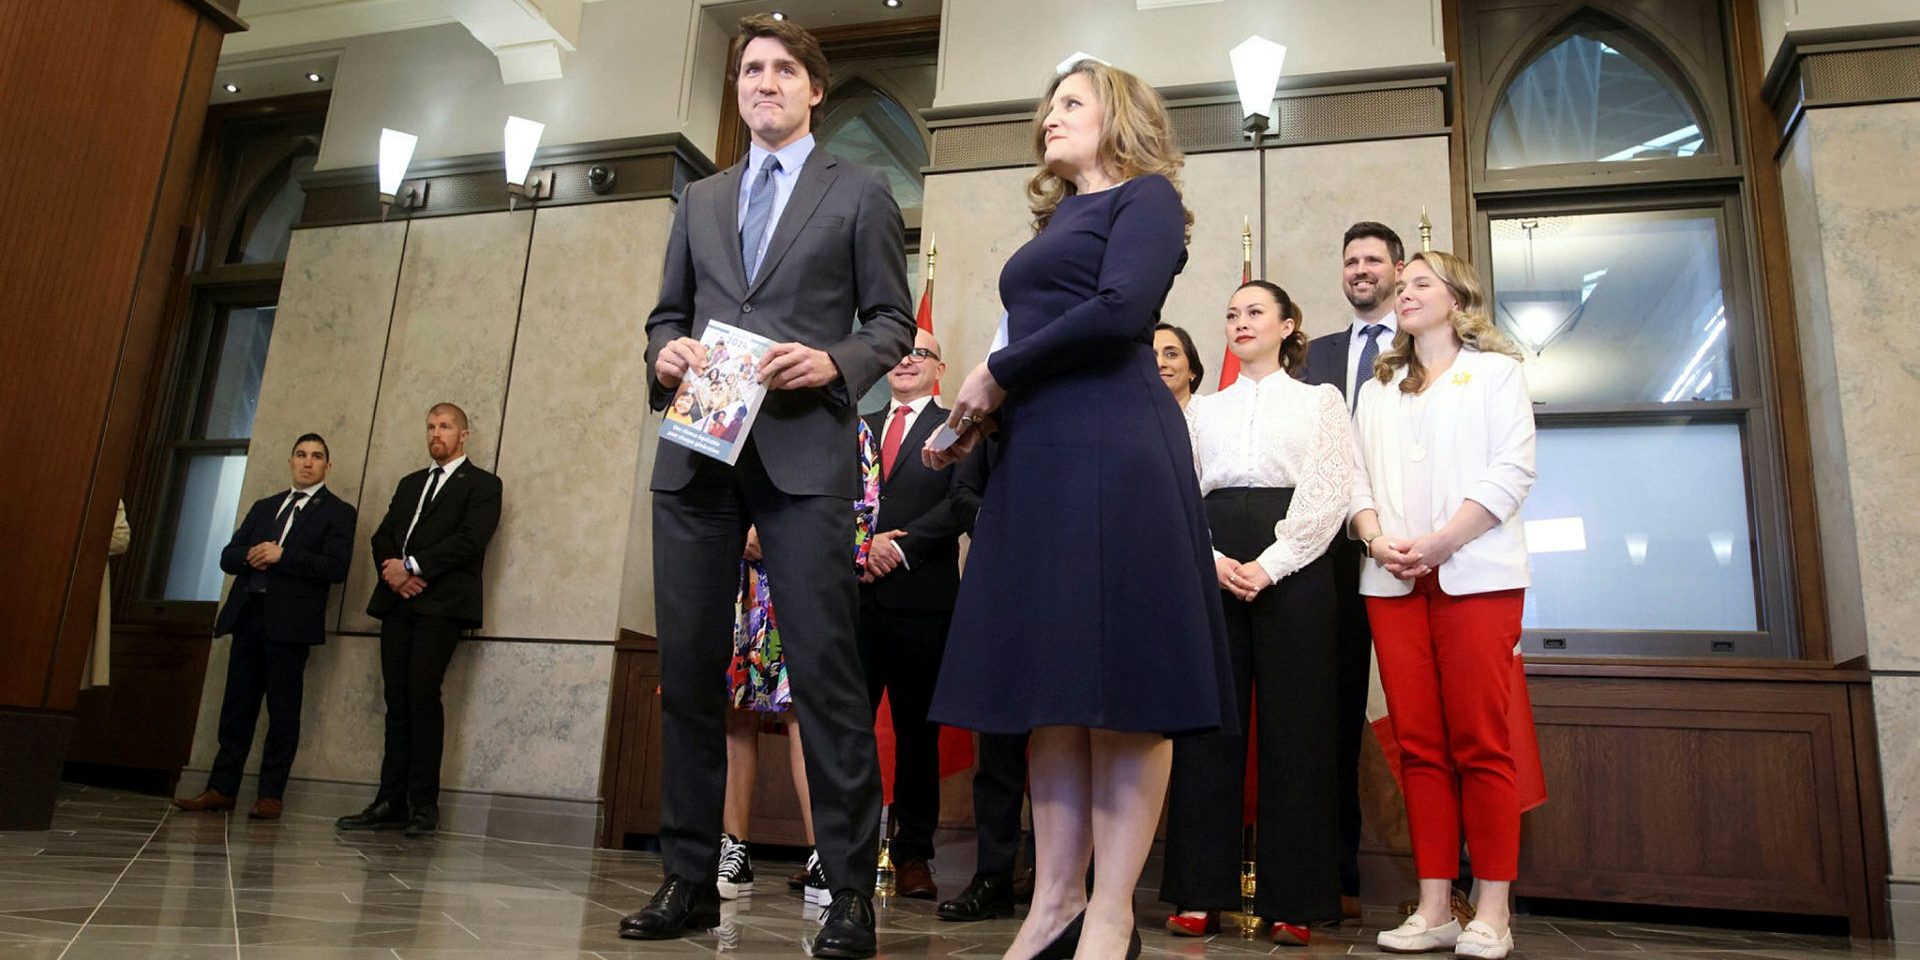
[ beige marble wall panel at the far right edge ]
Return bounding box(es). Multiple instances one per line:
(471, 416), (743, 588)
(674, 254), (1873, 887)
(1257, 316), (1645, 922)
(1805, 104), (1920, 668)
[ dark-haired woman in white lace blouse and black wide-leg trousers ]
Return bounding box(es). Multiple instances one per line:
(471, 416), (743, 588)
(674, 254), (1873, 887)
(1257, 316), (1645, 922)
(1160, 280), (1354, 945)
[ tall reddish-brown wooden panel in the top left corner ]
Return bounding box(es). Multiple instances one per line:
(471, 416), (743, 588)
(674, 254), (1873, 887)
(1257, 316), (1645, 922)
(0, 0), (221, 710)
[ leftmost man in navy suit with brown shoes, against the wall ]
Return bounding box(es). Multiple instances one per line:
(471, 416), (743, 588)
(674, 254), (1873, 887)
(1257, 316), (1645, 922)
(173, 434), (357, 820)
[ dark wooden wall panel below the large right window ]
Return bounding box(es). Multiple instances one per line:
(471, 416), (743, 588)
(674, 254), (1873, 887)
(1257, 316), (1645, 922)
(1515, 676), (1874, 935)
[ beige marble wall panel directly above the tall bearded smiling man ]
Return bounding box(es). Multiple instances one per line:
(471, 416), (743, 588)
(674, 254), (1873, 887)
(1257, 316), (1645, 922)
(1256, 136), (1453, 336)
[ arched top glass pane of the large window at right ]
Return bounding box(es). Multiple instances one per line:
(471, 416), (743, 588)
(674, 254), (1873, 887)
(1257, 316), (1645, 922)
(1486, 35), (1713, 169)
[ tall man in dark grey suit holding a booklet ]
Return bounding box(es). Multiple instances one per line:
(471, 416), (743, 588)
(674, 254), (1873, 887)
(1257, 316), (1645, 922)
(620, 15), (914, 958)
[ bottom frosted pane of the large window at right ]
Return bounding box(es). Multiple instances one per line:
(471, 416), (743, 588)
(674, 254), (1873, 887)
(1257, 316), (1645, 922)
(1521, 424), (1759, 632)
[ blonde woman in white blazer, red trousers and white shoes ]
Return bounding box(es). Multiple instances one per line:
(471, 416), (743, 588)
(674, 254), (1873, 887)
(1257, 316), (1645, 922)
(1350, 252), (1534, 960)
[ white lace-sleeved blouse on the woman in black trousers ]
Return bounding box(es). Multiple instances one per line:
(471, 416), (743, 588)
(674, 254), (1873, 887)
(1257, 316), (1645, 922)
(1187, 371), (1354, 582)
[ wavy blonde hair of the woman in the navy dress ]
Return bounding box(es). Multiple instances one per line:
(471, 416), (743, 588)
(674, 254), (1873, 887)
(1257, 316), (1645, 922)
(1027, 60), (1194, 240)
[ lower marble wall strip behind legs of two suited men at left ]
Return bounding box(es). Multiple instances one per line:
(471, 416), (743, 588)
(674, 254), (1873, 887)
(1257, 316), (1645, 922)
(182, 636), (612, 799)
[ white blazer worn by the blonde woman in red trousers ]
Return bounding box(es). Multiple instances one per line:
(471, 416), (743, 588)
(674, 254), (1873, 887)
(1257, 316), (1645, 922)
(1348, 348), (1534, 597)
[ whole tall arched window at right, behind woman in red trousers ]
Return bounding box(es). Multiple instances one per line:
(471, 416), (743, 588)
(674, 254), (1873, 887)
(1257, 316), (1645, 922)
(1461, 0), (1795, 657)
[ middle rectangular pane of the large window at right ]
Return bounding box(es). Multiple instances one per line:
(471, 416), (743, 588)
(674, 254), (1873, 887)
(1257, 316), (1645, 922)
(1490, 209), (1740, 403)
